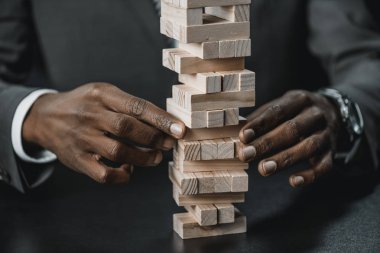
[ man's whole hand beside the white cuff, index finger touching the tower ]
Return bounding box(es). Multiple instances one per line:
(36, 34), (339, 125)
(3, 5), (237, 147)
(23, 83), (185, 183)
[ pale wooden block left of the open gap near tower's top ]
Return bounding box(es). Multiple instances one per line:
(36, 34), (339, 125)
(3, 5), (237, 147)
(161, 2), (203, 26)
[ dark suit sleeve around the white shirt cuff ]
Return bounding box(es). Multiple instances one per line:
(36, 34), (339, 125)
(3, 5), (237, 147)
(0, 0), (55, 192)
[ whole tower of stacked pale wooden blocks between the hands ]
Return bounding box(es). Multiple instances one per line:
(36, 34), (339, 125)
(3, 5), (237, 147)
(161, 0), (255, 239)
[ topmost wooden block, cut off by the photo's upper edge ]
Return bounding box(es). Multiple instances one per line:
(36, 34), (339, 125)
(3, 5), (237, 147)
(163, 0), (251, 9)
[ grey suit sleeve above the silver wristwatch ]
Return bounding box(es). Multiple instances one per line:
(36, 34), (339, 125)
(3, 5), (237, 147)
(308, 0), (380, 168)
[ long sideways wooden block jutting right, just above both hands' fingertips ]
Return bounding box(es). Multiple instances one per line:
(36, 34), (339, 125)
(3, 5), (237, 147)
(173, 85), (255, 111)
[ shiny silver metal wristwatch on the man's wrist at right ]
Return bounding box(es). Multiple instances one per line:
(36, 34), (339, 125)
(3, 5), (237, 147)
(318, 88), (364, 164)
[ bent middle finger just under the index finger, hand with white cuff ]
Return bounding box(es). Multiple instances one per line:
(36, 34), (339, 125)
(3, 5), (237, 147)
(99, 111), (175, 150)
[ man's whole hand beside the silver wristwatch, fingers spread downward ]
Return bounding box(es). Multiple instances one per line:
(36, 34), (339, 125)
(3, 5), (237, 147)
(238, 91), (340, 187)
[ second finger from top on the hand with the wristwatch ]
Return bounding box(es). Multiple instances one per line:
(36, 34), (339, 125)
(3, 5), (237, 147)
(244, 107), (325, 160)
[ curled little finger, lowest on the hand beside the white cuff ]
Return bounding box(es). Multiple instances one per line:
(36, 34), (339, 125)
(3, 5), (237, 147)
(79, 153), (133, 184)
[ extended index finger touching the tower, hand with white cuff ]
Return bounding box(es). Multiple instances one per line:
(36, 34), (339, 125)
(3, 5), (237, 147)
(100, 87), (186, 139)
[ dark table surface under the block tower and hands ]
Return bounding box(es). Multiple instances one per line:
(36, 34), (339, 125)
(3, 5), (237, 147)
(0, 162), (380, 253)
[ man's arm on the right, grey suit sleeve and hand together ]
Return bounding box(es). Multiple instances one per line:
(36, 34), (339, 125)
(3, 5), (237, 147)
(239, 0), (380, 187)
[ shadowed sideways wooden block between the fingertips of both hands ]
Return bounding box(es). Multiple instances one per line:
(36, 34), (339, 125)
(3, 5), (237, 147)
(183, 118), (247, 141)
